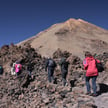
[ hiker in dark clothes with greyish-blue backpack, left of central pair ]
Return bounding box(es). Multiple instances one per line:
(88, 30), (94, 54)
(45, 57), (57, 83)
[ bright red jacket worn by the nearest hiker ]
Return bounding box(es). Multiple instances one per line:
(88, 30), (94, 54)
(83, 56), (100, 76)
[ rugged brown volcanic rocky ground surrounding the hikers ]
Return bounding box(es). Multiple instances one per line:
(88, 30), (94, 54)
(0, 44), (108, 108)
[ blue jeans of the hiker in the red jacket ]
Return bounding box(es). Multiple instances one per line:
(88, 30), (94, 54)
(85, 76), (97, 94)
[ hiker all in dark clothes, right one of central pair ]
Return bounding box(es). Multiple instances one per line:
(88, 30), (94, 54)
(59, 57), (69, 86)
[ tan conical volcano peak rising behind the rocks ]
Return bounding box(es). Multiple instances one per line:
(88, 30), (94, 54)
(19, 18), (108, 57)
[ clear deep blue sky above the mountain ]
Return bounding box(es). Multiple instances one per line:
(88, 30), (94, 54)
(0, 0), (108, 46)
